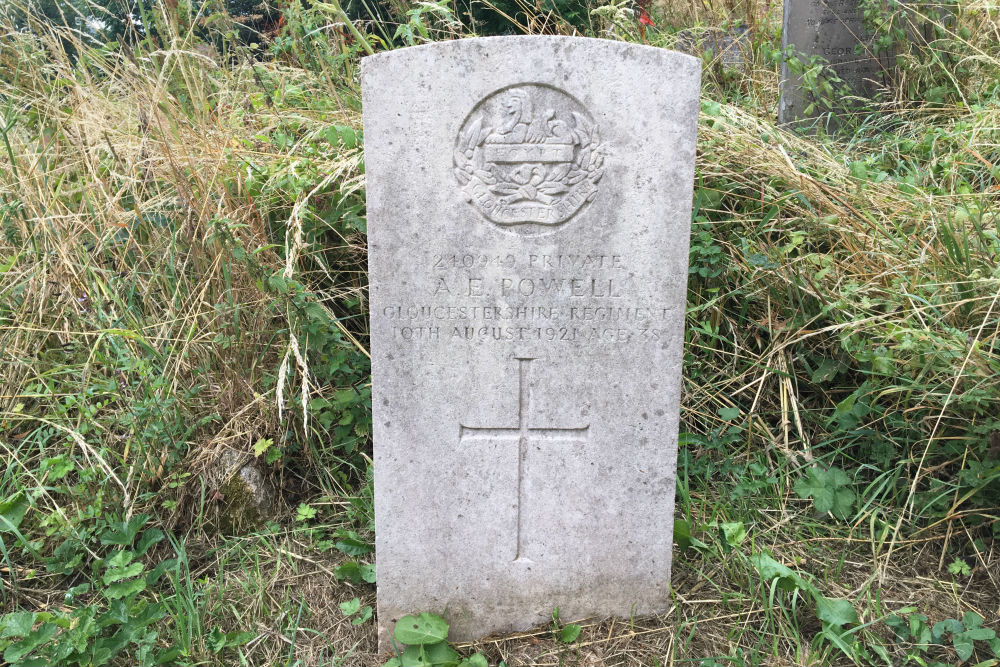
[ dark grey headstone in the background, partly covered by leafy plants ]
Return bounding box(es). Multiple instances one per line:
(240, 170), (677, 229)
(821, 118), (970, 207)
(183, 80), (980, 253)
(778, 0), (896, 124)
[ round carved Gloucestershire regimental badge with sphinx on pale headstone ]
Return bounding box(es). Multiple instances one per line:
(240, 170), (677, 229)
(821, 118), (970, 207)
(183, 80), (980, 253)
(454, 83), (604, 234)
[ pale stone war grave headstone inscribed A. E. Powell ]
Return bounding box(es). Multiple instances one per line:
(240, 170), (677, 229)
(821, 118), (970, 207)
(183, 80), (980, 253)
(362, 36), (700, 648)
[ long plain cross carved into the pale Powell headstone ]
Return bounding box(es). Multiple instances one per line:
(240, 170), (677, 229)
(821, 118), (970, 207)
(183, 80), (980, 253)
(458, 357), (590, 560)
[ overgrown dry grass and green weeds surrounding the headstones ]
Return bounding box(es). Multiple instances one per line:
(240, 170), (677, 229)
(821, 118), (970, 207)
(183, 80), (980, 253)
(0, 0), (1000, 666)
